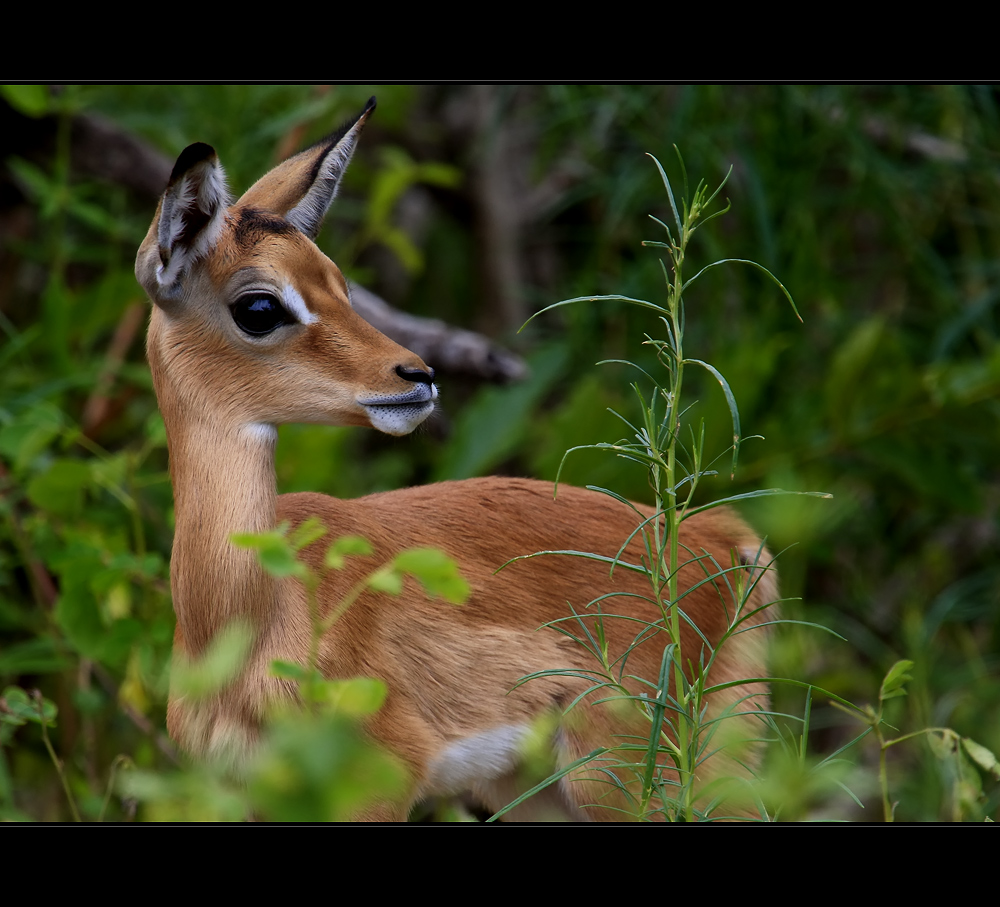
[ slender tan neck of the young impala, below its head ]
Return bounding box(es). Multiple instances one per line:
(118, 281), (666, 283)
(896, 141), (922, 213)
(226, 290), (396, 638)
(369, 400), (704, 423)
(164, 408), (277, 655)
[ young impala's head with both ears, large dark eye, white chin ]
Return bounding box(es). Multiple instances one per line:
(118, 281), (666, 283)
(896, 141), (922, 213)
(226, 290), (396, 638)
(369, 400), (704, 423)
(135, 98), (437, 435)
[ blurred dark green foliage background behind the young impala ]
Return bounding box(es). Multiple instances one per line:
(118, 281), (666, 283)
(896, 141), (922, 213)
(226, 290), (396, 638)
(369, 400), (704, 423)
(0, 85), (1000, 821)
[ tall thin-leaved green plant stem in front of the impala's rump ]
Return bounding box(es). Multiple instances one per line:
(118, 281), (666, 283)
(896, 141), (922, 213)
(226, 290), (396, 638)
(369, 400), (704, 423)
(498, 153), (828, 821)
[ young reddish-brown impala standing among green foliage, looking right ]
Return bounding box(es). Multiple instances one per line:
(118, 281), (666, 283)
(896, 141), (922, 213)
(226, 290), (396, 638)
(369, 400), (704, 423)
(136, 98), (776, 819)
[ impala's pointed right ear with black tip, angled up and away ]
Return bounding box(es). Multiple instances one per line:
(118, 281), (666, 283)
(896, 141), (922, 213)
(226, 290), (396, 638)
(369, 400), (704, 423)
(239, 97), (375, 239)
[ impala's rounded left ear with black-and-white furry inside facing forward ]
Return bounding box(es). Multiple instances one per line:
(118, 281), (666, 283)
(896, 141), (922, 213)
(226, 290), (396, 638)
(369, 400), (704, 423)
(135, 142), (230, 299)
